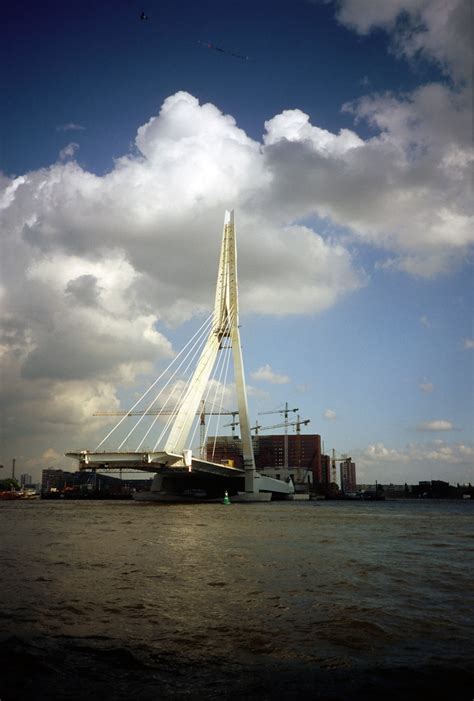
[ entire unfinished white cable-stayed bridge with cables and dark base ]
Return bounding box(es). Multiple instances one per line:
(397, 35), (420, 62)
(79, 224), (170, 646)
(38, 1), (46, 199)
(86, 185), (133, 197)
(66, 211), (294, 501)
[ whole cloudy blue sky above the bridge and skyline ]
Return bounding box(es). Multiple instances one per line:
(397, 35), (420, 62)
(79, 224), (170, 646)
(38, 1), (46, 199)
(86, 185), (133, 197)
(0, 0), (474, 484)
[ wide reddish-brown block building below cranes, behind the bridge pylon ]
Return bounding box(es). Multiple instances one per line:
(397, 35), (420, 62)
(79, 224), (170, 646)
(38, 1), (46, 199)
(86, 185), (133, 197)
(206, 433), (322, 485)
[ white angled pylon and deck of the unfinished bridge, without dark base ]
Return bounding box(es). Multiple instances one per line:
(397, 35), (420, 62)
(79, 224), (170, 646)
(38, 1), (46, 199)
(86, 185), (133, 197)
(66, 210), (294, 494)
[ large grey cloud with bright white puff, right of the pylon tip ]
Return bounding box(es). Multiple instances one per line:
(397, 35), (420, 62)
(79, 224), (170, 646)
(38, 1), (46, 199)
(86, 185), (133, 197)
(264, 78), (474, 277)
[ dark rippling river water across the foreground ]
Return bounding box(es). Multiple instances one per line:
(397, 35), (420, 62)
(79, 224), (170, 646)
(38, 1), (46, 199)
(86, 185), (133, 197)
(0, 500), (474, 701)
